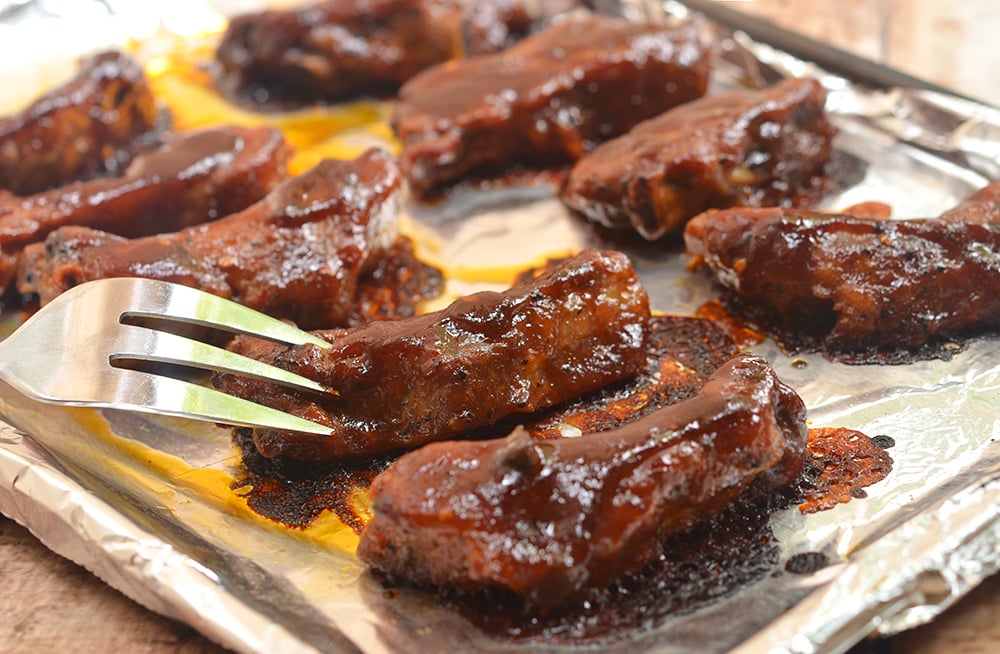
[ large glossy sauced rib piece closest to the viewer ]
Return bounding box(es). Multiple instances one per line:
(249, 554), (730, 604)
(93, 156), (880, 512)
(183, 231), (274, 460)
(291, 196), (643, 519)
(358, 355), (806, 609)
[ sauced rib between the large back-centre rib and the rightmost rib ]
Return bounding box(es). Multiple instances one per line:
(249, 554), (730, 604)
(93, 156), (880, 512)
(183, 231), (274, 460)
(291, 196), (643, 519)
(562, 79), (835, 240)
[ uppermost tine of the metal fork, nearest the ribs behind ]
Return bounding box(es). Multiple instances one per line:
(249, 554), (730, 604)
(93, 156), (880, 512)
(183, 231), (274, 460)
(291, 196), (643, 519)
(112, 278), (330, 348)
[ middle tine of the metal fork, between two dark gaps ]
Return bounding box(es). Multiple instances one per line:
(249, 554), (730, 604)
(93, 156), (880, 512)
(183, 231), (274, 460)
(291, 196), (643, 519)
(109, 325), (331, 393)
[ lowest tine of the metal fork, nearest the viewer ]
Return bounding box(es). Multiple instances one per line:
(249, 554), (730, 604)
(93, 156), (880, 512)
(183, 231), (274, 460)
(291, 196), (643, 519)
(91, 370), (333, 436)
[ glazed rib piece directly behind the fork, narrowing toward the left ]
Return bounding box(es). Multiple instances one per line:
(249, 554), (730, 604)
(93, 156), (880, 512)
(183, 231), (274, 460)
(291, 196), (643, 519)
(19, 150), (400, 327)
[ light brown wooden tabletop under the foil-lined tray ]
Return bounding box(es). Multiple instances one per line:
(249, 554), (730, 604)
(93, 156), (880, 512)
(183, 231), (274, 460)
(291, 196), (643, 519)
(0, 0), (1000, 654)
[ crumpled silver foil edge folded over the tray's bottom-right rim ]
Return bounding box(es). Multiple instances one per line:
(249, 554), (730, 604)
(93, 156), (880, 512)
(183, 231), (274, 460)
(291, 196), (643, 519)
(733, 471), (1000, 654)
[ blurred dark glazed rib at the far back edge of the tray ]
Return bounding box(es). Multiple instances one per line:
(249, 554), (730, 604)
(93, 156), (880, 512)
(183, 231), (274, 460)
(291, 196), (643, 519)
(216, 0), (531, 101)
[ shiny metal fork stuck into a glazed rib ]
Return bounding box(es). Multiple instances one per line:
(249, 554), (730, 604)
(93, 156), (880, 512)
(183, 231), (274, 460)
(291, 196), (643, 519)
(0, 278), (331, 435)
